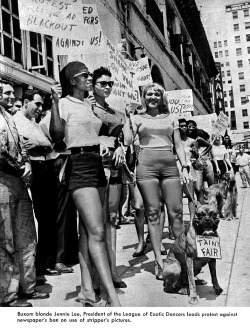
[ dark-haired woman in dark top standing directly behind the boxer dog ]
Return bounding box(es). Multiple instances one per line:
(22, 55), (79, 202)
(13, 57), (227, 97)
(187, 120), (214, 204)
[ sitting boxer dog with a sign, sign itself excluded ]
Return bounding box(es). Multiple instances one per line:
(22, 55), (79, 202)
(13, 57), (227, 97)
(163, 203), (223, 304)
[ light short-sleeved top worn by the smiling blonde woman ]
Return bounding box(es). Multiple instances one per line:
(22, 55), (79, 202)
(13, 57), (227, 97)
(132, 114), (179, 149)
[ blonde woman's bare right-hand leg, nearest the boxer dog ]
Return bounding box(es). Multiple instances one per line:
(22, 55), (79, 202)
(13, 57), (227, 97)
(160, 179), (184, 238)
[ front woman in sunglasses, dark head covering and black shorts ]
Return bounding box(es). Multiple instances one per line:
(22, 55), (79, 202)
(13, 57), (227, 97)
(50, 62), (120, 307)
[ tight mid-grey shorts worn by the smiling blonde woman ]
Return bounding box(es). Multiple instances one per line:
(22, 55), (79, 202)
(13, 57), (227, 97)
(136, 149), (180, 181)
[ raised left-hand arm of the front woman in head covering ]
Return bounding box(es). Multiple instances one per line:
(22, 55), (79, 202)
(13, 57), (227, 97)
(49, 84), (65, 143)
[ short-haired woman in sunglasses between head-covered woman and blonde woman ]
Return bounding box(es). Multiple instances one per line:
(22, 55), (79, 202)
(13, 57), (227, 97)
(93, 67), (132, 288)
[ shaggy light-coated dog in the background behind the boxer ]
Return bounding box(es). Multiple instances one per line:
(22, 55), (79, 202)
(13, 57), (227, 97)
(207, 172), (238, 221)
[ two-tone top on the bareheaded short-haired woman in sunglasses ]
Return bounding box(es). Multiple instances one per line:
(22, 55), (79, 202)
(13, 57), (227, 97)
(93, 103), (124, 148)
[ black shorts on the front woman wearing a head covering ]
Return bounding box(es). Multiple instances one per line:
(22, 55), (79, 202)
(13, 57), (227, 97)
(69, 151), (106, 191)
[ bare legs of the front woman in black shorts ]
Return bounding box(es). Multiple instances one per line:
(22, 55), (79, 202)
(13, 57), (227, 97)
(72, 188), (120, 306)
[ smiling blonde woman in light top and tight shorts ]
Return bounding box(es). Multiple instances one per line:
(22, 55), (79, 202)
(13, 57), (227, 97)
(128, 83), (188, 280)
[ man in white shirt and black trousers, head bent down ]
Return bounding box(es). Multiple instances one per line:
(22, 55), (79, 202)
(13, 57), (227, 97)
(13, 90), (60, 284)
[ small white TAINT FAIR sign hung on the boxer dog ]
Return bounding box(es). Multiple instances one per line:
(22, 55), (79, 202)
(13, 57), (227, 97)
(196, 236), (222, 259)
